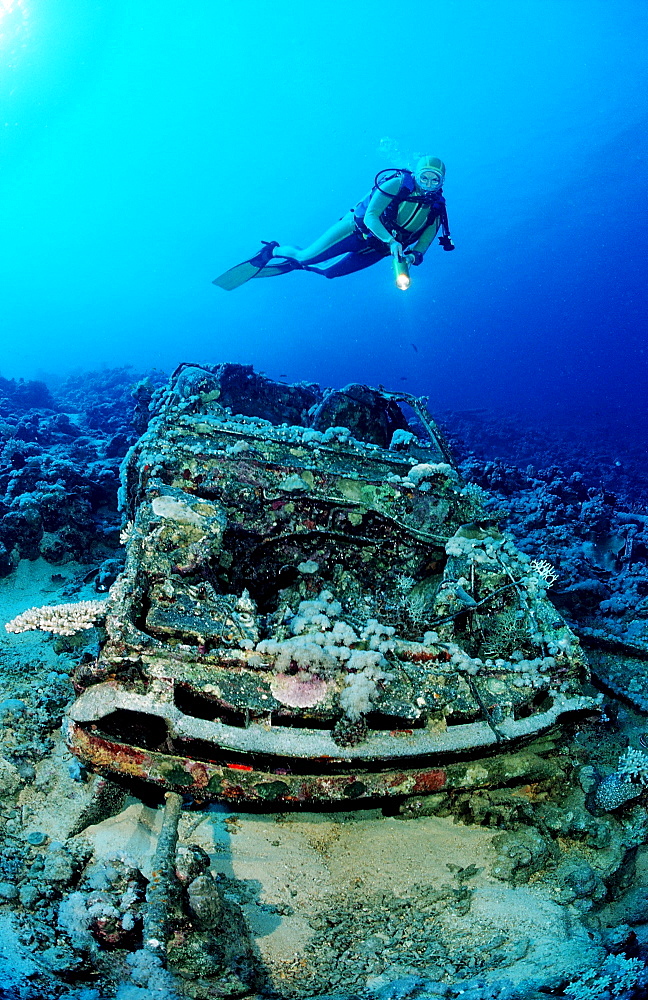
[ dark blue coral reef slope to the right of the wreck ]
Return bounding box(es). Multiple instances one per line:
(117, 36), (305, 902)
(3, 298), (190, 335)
(444, 412), (648, 711)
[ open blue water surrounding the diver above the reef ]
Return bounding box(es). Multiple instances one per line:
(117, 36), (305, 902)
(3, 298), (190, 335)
(0, 0), (648, 428)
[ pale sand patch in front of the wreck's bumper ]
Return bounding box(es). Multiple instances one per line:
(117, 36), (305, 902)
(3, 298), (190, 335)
(177, 811), (601, 995)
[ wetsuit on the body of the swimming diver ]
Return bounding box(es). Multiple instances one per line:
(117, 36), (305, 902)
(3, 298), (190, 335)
(255, 176), (441, 278)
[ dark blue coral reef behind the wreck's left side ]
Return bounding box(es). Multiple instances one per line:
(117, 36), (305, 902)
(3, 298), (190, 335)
(0, 368), (167, 589)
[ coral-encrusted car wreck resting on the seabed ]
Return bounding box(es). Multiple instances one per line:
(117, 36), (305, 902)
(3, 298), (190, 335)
(66, 364), (597, 806)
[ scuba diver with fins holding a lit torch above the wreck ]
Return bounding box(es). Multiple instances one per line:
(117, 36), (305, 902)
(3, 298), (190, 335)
(213, 156), (454, 291)
